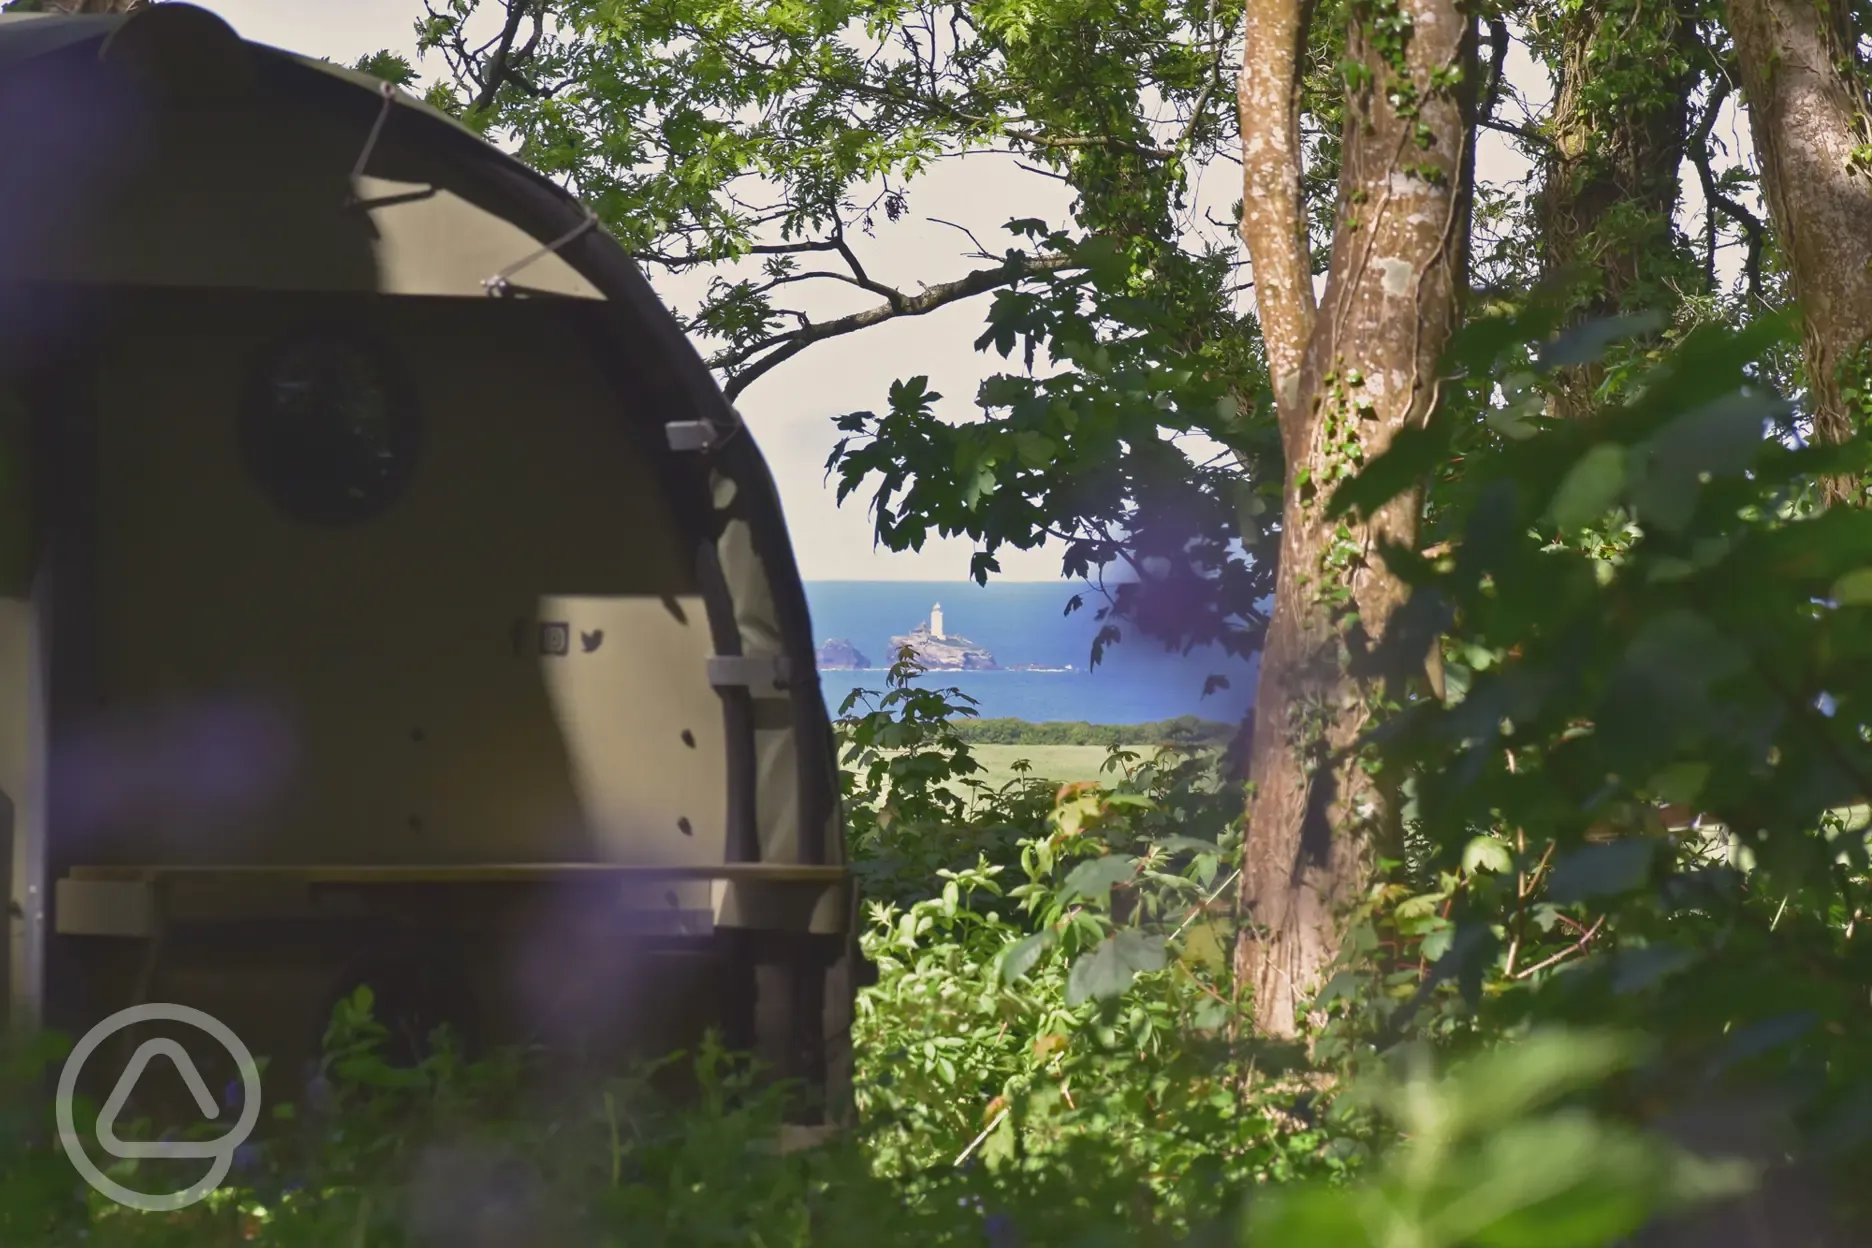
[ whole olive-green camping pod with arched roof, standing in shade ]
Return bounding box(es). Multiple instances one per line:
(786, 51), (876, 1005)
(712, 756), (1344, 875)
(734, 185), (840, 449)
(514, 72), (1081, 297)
(0, 4), (856, 1122)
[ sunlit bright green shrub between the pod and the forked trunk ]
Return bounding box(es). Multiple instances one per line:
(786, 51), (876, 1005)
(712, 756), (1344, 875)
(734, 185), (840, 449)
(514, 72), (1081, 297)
(857, 669), (1267, 1207)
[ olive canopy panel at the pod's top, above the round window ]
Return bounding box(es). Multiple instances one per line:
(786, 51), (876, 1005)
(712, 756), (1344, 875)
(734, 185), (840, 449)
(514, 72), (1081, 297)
(0, 4), (603, 299)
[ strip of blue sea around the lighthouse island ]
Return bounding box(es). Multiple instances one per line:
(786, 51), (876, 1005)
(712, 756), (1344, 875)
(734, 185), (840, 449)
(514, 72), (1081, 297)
(805, 580), (1254, 724)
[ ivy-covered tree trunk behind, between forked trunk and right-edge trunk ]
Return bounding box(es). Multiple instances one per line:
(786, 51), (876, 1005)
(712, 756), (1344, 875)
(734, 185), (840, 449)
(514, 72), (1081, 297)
(1535, 0), (1698, 417)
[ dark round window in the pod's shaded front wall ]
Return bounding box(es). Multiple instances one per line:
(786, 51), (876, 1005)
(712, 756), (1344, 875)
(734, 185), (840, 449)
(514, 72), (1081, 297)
(241, 333), (419, 526)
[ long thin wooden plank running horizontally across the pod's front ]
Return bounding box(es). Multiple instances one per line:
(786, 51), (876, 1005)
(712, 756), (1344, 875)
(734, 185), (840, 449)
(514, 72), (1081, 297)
(67, 863), (850, 885)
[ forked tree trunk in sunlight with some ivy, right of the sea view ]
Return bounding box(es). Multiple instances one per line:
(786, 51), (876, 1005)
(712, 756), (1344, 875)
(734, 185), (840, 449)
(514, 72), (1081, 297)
(1236, 0), (1475, 1037)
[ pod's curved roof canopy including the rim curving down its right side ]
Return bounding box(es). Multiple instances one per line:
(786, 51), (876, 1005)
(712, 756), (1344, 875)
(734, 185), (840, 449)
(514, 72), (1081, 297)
(0, 4), (842, 886)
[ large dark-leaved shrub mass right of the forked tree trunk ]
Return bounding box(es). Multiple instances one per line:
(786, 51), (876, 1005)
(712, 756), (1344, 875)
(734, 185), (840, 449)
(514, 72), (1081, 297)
(1327, 310), (1872, 1227)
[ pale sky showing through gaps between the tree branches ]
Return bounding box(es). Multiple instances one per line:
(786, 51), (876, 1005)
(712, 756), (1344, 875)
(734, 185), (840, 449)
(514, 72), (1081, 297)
(195, 0), (1741, 580)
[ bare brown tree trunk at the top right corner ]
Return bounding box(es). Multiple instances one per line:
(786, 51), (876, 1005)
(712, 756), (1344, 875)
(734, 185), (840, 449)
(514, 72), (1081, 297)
(1730, 0), (1872, 501)
